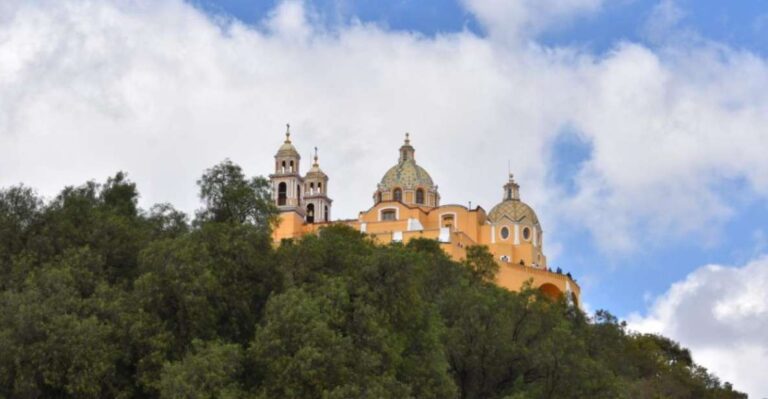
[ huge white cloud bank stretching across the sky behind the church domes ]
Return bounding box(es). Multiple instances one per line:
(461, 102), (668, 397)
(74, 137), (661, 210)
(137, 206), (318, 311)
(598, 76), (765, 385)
(0, 0), (768, 255)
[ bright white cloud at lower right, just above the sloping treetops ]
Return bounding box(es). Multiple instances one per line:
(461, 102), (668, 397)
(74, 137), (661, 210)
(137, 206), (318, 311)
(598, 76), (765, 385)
(629, 256), (768, 398)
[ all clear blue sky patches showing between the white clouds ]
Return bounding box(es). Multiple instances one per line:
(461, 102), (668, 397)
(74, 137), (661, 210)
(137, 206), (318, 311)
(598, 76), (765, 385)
(186, 0), (768, 315)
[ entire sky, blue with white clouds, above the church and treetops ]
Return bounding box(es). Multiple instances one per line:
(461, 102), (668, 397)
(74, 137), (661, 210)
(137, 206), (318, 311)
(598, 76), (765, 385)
(0, 0), (768, 398)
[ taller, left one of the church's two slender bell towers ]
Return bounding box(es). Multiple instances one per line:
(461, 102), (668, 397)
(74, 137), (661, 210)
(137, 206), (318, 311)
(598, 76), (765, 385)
(269, 125), (304, 216)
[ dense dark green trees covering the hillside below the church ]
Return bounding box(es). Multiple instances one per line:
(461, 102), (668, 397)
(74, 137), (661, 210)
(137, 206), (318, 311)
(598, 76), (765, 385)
(0, 161), (746, 399)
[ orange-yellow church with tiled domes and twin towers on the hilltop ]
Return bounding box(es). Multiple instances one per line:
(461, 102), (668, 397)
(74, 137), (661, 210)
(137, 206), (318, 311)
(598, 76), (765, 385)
(269, 129), (580, 306)
